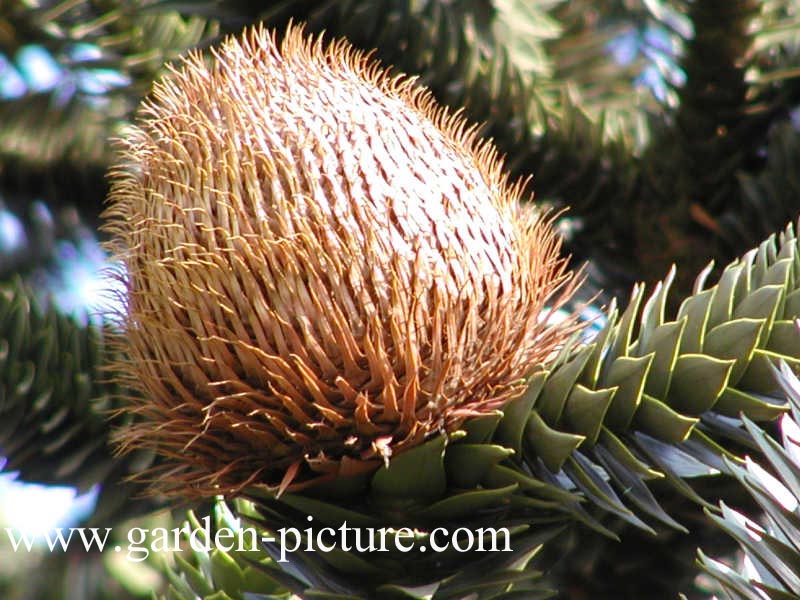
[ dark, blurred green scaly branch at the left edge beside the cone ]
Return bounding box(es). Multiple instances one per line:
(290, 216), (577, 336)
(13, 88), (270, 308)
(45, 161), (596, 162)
(0, 280), (155, 524)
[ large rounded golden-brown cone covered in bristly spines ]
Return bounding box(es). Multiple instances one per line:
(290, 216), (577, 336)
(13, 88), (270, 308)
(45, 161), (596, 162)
(106, 27), (576, 496)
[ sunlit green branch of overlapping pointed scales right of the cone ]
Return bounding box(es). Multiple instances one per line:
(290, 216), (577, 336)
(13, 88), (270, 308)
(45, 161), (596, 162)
(495, 225), (800, 529)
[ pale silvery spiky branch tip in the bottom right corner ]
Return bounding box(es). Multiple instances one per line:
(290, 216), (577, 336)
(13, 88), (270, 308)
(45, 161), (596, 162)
(698, 358), (800, 600)
